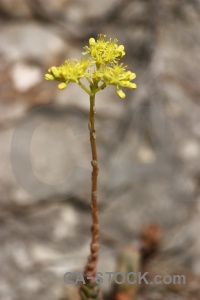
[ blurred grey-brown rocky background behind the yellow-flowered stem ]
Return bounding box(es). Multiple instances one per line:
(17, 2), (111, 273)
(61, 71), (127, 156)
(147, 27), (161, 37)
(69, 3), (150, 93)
(0, 0), (200, 300)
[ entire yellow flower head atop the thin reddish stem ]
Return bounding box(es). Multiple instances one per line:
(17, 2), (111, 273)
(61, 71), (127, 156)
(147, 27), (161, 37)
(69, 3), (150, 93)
(45, 34), (137, 98)
